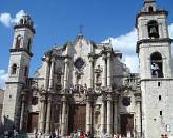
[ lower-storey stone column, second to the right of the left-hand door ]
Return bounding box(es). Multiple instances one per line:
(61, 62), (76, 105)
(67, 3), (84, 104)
(46, 93), (52, 134)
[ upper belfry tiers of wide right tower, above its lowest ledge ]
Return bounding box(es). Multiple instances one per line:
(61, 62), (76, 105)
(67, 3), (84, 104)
(136, 0), (172, 79)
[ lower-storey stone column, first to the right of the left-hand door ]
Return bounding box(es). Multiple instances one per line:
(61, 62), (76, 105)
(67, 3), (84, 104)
(39, 92), (46, 133)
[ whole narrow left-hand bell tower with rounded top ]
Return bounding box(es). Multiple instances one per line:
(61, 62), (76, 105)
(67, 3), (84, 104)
(2, 13), (35, 130)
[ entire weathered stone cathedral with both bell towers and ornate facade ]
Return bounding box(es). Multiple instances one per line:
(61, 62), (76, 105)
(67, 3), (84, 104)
(1, 0), (173, 138)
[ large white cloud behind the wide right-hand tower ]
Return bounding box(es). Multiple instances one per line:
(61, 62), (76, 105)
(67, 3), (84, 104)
(104, 23), (173, 73)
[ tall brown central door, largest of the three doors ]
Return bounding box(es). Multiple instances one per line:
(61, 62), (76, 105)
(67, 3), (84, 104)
(68, 104), (86, 133)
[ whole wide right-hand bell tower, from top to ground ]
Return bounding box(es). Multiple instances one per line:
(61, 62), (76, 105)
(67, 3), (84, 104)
(136, 0), (173, 138)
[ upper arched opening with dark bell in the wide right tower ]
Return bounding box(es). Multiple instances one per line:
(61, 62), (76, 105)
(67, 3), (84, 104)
(148, 21), (159, 38)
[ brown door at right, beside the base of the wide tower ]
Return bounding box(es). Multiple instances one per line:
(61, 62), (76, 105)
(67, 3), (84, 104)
(120, 114), (134, 137)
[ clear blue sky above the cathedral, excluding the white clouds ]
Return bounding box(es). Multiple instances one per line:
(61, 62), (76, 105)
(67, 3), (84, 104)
(0, 0), (173, 88)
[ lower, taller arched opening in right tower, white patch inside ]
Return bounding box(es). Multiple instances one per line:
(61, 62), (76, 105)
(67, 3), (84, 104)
(150, 52), (164, 78)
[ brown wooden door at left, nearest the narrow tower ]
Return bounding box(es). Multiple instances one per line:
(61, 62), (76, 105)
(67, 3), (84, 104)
(27, 113), (38, 133)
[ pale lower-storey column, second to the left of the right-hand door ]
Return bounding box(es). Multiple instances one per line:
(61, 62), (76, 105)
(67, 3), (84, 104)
(107, 94), (113, 136)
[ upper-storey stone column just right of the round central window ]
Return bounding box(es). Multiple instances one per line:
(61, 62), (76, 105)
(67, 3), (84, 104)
(89, 57), (94, 89)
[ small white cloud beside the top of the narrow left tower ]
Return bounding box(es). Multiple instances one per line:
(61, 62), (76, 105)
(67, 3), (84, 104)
(0, 10), (25, 28)
